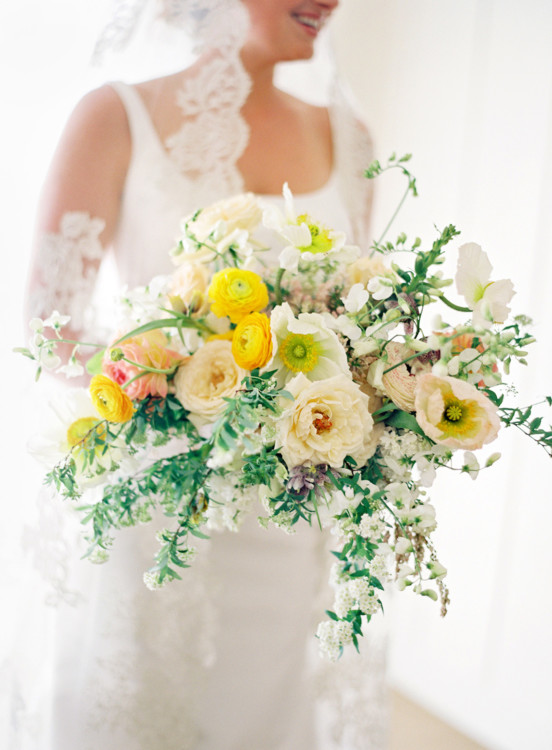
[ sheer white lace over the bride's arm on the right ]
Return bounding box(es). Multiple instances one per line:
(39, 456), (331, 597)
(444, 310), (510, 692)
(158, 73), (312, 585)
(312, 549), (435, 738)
(330, 85), (373, 252)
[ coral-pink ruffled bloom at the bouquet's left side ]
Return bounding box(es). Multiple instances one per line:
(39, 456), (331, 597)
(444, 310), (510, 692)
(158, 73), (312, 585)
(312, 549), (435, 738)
(102, 330), (183, 399)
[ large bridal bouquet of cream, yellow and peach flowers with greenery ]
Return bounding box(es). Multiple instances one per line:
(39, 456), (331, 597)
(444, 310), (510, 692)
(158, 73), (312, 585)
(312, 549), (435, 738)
(19, 157), (552, 659)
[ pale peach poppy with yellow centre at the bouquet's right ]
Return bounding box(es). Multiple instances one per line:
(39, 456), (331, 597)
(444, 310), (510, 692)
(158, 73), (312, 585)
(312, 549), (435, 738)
(415, 373), (500, 450)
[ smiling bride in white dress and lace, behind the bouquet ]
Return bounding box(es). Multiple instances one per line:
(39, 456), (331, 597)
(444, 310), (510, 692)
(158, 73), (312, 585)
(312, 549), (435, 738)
(16, 0), (386, 750)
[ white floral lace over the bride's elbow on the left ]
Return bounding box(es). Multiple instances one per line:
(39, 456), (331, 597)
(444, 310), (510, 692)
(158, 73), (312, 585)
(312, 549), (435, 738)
(29, 211), (105, 331)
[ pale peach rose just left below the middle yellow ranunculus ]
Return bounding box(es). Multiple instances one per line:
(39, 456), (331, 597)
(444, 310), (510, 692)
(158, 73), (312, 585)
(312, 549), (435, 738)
(174, 340), (247, 421)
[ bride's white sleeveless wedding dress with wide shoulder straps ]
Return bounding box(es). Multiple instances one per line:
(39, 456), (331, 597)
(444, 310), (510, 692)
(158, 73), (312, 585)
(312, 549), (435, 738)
(8, 79), (387, 750)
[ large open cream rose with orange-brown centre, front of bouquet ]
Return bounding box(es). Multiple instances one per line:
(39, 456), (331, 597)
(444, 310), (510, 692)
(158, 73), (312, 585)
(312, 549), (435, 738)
(276, 373), (378, 468)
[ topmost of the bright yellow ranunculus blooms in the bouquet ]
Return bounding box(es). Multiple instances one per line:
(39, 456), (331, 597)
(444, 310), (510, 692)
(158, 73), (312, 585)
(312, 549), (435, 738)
(209, 268), (268, 323)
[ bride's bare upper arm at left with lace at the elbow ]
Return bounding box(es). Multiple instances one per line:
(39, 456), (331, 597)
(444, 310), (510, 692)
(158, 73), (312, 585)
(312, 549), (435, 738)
(25, 86), (131, 364)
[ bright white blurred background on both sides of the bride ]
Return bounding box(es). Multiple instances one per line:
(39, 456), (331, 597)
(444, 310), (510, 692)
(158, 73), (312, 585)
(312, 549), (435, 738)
(0, 0), (552, 750)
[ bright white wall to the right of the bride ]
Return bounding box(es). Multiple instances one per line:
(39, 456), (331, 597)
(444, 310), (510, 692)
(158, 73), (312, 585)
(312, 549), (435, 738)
(337, 0), (552, 750)
